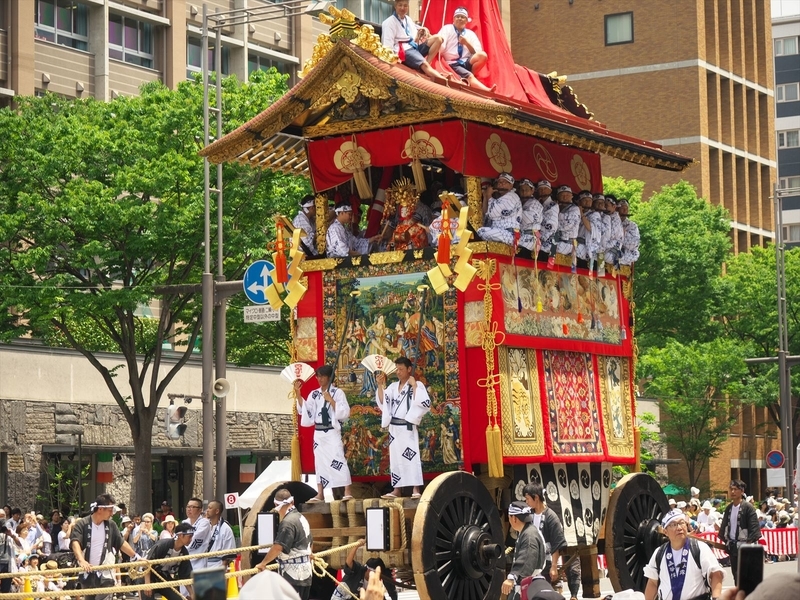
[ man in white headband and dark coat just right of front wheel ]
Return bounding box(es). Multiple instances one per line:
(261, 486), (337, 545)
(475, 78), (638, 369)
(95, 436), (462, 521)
(500, 501), (546, 600)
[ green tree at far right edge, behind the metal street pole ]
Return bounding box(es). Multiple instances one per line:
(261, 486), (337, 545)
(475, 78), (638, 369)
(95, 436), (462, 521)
(718, 245), (800, 447)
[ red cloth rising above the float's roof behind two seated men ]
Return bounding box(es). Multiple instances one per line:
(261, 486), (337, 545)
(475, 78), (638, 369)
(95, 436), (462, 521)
(420, 0), (567, 112)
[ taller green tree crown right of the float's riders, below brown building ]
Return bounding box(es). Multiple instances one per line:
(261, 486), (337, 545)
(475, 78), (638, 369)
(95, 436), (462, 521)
(632, 181), (731, 350)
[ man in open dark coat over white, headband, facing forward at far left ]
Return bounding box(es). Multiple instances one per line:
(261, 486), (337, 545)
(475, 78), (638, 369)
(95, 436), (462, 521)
(70, 494), (141, 600)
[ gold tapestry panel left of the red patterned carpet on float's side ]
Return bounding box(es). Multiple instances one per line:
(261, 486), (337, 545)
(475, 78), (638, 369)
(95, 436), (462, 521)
(498, 346), (545, 457)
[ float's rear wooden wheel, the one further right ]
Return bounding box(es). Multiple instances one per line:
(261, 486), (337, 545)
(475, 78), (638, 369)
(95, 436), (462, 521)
(605, 473), (669, 592)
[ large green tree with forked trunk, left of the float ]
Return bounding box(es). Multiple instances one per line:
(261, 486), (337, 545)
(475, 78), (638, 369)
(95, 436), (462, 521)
(0, 71), (307, 511)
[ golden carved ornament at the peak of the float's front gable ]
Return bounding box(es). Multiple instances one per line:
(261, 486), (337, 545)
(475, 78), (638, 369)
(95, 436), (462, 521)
(299, 6), (399, 78)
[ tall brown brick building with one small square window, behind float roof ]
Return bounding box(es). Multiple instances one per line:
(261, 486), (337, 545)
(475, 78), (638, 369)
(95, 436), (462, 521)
(510, 0), (776, 252)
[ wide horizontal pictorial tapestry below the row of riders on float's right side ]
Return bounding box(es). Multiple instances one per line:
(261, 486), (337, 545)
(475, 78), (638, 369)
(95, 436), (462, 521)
(500, 264), (622, 345)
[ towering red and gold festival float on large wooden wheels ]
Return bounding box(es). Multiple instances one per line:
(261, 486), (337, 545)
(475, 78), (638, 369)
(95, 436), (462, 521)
(202, 0), (692, 600)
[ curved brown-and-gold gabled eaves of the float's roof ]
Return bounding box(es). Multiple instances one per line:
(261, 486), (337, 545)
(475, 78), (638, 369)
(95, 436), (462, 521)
(200, 40), (694, 176)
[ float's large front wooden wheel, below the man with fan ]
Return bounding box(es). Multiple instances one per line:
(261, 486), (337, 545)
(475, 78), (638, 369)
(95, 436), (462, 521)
(411, 471), (505, 600)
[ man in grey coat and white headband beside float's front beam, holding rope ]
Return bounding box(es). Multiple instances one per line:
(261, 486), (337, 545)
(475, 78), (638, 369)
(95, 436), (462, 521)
(256, 488), (312, 600)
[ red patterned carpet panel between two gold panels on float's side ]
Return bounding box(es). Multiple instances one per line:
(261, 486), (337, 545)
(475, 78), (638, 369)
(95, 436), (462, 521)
(542, 350), (603, 456)
